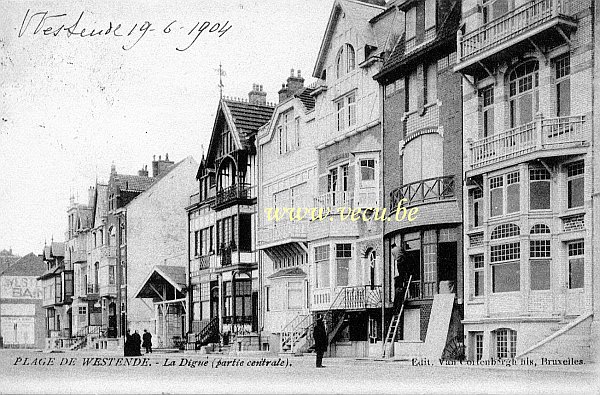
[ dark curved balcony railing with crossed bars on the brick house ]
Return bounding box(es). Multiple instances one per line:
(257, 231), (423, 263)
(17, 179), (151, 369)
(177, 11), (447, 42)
(390, 176), (455, 210)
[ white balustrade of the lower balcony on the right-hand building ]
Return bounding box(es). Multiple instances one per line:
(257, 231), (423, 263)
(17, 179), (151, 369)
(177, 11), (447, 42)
(470, 115), (586, 169)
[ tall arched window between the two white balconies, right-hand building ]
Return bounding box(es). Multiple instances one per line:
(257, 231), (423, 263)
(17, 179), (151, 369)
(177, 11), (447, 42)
(509, 60), (539, 128)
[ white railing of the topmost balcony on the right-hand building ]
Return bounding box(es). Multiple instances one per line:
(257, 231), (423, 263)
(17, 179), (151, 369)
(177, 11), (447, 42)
(457, 0), (571, 63)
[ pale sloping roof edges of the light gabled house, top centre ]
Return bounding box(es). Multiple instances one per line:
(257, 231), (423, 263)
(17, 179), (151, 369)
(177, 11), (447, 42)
(313, 0), (386, 78)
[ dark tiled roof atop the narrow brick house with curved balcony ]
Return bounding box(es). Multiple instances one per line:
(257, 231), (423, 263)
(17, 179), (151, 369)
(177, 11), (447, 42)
(373, 1), (461, 80)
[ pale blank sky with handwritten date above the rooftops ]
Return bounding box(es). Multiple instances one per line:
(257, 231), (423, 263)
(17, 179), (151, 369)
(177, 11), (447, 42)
(0, 0), (333, 255)
